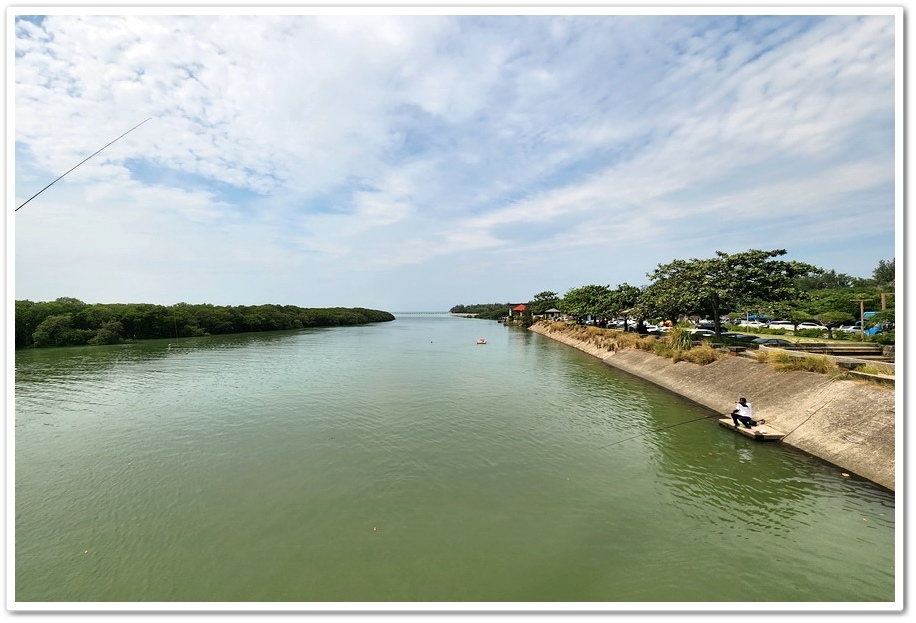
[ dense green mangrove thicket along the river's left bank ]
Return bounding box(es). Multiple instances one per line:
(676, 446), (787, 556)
(16, 298), (394, 348)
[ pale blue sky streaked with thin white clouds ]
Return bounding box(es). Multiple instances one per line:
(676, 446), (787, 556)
(7, 7), (903, 312)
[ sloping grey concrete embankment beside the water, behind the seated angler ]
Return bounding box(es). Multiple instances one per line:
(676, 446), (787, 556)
(531, 323), (902, 490)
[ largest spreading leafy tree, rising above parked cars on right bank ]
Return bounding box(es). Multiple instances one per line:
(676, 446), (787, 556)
(643, 249), (817, 333)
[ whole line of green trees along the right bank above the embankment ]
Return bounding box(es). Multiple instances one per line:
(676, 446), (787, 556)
(452, 249), (895, 343)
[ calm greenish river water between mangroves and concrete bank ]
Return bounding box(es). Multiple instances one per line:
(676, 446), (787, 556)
(11, 315), (895, 604)
